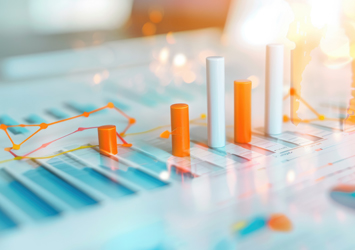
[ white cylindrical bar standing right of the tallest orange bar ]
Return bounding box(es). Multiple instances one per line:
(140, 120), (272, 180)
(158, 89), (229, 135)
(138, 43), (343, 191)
(265, 44), (284, 135)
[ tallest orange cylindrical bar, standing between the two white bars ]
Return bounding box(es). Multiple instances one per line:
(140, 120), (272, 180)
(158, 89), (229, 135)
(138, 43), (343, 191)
(234, 80), (251, 143)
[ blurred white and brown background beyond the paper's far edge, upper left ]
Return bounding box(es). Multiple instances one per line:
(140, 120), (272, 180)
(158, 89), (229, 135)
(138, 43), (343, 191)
(0, 0), (231, 59)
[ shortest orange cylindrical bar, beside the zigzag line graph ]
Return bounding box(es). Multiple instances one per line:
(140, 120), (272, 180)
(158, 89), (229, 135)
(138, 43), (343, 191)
(97, 125), (117, 155)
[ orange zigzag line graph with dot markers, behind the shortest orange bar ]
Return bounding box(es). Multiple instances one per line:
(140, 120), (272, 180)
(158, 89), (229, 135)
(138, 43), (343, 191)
(0, 102), (136, 151)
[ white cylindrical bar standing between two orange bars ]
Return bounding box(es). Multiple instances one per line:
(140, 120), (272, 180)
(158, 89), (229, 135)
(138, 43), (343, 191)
(206, 56), (226, 148)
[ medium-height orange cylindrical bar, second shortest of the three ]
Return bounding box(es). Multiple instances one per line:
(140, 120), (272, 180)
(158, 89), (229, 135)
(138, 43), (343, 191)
(170, 103), (190, 157)
